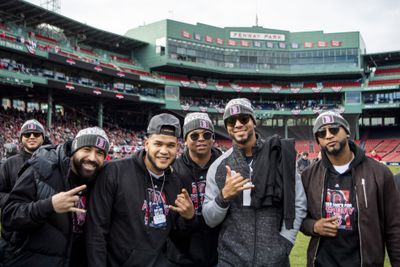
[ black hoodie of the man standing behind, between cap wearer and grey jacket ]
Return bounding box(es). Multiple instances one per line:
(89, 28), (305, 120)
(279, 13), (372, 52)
(169, 147), (222, 267)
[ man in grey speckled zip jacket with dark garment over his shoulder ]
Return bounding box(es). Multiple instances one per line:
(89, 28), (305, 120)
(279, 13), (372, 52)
(203, 98), (306, 266)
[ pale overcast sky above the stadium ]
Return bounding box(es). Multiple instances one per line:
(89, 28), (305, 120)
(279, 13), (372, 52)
(28, 0), (400, 53)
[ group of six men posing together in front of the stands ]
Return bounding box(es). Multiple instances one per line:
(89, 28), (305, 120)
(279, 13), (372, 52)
(0, 98), (400, 267)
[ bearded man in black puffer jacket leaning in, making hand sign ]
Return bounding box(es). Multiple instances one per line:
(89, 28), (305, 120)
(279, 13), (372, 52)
(2, 127), (109, 267)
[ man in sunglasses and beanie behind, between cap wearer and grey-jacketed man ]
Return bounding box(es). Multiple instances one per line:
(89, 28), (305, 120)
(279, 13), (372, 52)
(171, 112), (221, 267)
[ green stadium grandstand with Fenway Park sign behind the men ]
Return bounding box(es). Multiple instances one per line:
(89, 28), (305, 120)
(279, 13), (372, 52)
(0, 0), (400, 162)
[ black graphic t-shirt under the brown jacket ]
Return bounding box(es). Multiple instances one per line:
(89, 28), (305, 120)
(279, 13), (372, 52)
(315, 170), (360, 267)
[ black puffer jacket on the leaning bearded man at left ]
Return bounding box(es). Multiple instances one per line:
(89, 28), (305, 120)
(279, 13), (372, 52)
(2, 143), (85, 267)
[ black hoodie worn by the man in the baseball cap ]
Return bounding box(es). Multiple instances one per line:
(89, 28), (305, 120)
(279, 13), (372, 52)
(86, 150), (192, 267)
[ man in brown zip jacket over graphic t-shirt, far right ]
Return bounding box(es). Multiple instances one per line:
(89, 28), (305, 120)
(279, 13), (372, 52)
(301, 111), (400, 267)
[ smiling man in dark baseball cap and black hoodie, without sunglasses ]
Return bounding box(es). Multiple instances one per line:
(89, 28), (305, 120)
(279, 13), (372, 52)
(86, 113), (195, 267)
